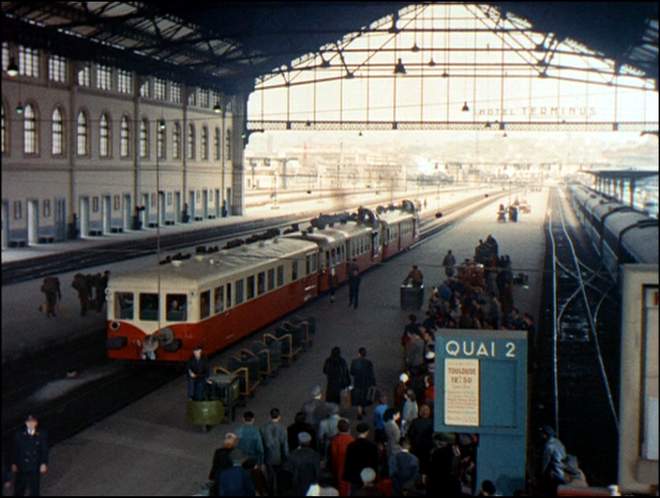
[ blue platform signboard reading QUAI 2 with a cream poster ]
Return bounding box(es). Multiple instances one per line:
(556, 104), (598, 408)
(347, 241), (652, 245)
(434, 329), (527, 496)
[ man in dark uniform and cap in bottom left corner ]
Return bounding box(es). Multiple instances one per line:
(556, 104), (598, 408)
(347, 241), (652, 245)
(11, 415), (48, 496)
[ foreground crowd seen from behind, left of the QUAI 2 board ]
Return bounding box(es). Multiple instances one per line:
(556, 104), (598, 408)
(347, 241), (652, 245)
(201, 344), (495, 496)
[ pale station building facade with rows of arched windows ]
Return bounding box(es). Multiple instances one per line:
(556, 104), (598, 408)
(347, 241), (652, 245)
(1, 42), (245, 248)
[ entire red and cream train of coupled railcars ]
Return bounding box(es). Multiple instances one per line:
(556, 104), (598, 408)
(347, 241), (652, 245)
(107, 201), (419, 362)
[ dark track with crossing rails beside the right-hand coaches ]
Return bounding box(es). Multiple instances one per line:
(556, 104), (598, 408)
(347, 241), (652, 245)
(536, 189), (619, 484)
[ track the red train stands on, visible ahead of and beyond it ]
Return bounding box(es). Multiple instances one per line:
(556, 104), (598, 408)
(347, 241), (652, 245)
(2, 189), (508, 450)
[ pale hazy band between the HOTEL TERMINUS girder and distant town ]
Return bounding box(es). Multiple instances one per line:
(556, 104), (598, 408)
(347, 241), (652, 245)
(246, 131), (659, 169)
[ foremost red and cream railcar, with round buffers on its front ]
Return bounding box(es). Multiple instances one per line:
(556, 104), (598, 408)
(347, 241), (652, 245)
(108, 237), (319, 362)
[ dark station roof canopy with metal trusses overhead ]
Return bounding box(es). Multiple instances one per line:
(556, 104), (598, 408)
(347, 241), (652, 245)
(2, 1), (658, 87)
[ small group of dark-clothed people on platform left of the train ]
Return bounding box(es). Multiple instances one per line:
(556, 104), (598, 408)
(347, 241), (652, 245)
(39, 271), (110, 318)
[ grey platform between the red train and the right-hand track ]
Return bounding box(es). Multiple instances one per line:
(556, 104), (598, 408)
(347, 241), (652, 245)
(36, 191), (548, 496)
